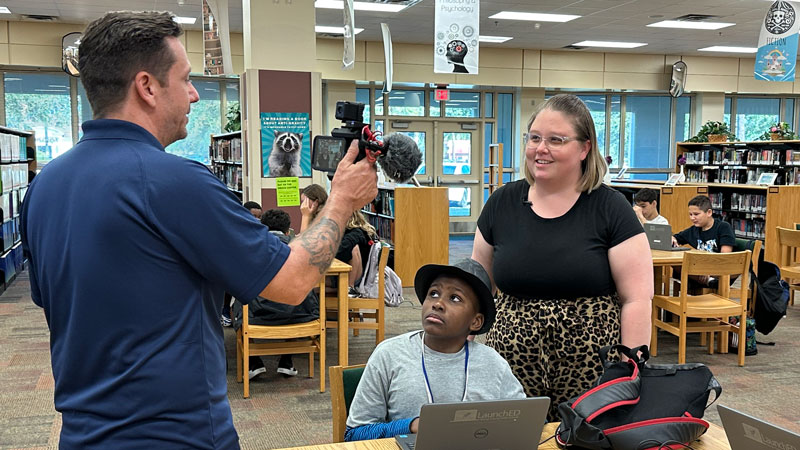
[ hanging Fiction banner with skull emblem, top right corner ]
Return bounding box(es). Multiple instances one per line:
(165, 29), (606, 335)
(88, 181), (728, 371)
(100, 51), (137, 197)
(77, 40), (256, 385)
(754, 1), (800, 81)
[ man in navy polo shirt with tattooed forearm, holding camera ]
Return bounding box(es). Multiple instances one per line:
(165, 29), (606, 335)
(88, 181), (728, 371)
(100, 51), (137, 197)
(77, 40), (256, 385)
(22, 12), (377, 449)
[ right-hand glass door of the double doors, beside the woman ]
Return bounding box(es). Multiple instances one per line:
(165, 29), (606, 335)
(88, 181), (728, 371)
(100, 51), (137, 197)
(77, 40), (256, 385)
(432, 122), (483, 222)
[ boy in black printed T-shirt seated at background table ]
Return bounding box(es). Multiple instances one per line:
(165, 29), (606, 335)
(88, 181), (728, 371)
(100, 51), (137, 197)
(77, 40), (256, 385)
(672, 195), (736, 287)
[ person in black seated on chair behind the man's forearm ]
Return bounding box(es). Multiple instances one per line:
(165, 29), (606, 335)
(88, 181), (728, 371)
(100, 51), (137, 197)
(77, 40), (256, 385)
(234, 209), (319, 379)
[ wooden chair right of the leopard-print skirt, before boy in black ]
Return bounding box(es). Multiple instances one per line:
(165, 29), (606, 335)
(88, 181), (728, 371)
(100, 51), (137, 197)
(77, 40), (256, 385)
(650, 250), (752, 366)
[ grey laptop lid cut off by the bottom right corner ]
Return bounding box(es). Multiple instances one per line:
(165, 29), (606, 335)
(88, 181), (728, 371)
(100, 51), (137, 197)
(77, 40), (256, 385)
(717, 405), (800, 450)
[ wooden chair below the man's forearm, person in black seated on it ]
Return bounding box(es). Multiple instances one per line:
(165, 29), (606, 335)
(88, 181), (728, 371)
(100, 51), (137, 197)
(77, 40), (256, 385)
(236, 296), (325, 398)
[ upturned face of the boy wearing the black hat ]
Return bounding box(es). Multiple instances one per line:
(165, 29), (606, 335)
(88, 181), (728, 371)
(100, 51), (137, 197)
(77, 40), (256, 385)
(422, 276), (483, 339)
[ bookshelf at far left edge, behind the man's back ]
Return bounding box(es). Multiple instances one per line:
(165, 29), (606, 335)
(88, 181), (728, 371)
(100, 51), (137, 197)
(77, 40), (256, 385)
(0, 127), (36, 292)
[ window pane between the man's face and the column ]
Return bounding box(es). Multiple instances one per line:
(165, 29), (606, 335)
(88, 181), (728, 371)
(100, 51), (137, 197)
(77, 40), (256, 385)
(166, 81), (222, 164)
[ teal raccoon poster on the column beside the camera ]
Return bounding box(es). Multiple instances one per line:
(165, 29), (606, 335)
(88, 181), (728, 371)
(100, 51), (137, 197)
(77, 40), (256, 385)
(261, 113), (311, 177)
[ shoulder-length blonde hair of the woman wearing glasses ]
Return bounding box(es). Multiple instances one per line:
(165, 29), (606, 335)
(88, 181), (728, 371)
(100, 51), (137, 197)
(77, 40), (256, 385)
(522, 94), (608, 193)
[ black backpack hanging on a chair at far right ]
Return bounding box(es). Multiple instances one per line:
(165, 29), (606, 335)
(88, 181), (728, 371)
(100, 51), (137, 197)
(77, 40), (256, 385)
(752, 261), (789, 334)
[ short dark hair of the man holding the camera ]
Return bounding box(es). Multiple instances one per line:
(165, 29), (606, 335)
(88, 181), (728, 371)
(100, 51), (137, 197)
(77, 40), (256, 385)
(78, 11), (183, 118)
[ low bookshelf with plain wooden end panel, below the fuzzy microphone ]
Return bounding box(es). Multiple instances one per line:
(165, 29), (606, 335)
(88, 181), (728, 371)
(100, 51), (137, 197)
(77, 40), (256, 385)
(362, 184), (450, 286)
